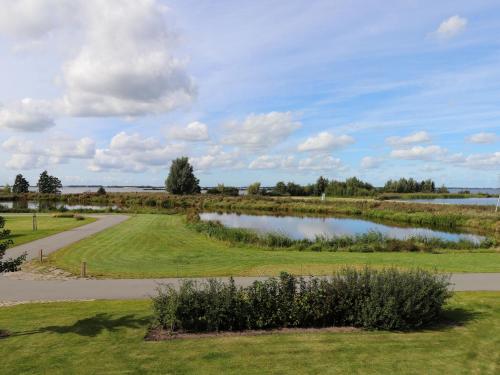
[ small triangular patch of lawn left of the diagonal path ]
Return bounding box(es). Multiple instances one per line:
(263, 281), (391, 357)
(0, 214), (96, 247)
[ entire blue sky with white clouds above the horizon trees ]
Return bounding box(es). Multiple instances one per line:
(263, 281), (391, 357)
(0, 0), (500, 187)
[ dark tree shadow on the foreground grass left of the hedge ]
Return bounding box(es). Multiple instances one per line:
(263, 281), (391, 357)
(11, 313), (149, 337)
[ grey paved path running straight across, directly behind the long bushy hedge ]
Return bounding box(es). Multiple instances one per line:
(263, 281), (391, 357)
(0, 273), (500, 301)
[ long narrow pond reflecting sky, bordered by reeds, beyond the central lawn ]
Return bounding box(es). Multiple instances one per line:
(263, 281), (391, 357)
(200, 212), (484, 243)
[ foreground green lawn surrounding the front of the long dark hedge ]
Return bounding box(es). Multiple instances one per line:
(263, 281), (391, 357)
(0, 292), (500, 375)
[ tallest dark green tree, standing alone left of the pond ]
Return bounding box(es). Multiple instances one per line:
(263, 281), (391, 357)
(165, 157), (201, 194)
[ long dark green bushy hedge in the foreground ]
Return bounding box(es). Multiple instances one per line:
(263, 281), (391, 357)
(153, 268), (451, 332)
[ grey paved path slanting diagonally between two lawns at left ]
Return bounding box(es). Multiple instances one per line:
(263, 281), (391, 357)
(6, 215), (129, 260)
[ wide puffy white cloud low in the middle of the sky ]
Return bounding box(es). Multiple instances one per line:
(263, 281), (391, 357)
(222, 112), (301, 150)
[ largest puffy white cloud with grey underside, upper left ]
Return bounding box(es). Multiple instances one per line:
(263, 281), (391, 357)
(63, 0), (195, 116)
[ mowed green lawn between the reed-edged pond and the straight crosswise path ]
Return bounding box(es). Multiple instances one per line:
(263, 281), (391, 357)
(49, 215), (500, 278)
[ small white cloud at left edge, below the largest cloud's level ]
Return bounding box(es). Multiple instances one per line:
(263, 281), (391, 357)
(0, 98), (55, 132)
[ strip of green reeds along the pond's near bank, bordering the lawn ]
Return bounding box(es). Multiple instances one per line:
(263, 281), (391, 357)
(188, 220), (497, 252)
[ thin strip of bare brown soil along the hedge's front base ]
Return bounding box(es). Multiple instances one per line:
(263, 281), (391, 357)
(145, 327), (361, 341)
